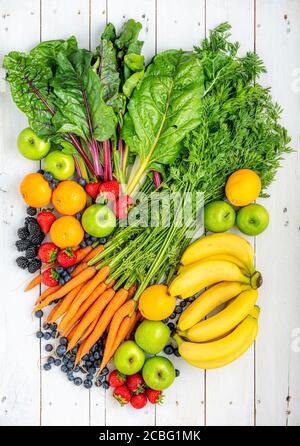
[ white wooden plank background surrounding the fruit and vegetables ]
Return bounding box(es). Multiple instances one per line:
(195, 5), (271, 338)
(0, 0), (300, 426)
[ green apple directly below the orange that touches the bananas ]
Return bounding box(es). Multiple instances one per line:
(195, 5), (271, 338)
(134, 321), (170, 355)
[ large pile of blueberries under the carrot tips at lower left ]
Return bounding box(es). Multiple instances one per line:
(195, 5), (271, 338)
(35, 310), (110, 389)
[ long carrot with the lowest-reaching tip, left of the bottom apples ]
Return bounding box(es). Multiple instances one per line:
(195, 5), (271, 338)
(100, 299), (135, 371)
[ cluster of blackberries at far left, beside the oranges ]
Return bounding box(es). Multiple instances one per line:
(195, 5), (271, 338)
(15, 207), (45, 274)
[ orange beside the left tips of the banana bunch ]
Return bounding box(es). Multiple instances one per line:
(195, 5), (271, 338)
(139, 285), (176, 321)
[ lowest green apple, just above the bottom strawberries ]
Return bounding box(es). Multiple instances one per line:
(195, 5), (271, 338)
(142, 356), (175, 390)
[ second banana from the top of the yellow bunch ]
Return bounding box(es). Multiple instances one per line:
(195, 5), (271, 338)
(169, 260), (250, 298)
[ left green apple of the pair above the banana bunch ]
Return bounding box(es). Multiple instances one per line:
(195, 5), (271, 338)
(204, 201), (235, 232)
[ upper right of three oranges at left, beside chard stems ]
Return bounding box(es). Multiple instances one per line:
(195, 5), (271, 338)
(52, 180), (86, 215)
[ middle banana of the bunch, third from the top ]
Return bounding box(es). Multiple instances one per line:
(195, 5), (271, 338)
(178, 282), (250, 331)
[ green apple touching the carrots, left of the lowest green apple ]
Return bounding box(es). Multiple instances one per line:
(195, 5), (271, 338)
(114, 341), (145, 375)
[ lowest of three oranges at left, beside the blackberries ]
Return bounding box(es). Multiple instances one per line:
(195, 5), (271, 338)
(50, 216), (84, 249)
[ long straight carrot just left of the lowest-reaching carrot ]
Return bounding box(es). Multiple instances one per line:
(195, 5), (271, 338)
(75, 288), (128, 364)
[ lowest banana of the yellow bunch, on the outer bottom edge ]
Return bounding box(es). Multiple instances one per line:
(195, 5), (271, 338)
(174, 308), (258, 367)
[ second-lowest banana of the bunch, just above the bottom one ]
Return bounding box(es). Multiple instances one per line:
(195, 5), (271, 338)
(179, 290), (258, 342)
